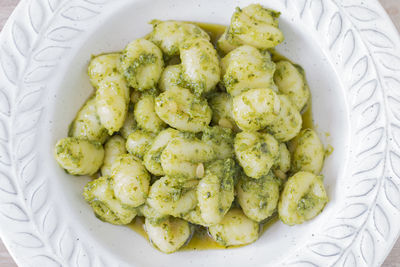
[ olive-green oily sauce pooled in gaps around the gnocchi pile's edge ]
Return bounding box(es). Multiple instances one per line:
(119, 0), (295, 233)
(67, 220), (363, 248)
(128, 22), (314, 250)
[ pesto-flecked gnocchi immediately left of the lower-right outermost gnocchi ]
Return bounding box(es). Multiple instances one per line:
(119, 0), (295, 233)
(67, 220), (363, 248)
(236, 174), (279, 222)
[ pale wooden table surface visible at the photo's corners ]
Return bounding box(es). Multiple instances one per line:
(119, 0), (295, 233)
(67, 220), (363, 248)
(0, 0), (400, 267)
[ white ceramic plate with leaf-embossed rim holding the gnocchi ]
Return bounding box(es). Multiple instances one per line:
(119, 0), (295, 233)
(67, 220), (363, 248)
(0, 0), (400, 267)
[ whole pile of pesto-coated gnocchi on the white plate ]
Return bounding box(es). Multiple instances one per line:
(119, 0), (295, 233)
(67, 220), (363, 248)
(55, 4), (328, 253)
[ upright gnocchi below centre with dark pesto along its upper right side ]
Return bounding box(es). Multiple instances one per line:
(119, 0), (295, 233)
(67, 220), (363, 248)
(197, 159), (235, 225)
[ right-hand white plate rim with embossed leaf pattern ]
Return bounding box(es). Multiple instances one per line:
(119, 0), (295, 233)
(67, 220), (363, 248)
(288, 0), (400, 266)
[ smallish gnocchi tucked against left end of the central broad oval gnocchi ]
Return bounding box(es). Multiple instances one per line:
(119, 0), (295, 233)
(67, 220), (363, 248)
(134, 94), (166, 134)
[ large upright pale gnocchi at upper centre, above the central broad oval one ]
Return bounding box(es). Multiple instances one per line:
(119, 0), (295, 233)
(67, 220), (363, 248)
(180, 38), (221, 95)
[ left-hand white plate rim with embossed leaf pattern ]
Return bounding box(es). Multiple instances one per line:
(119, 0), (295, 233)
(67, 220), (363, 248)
(0, 0), (105, 267)
